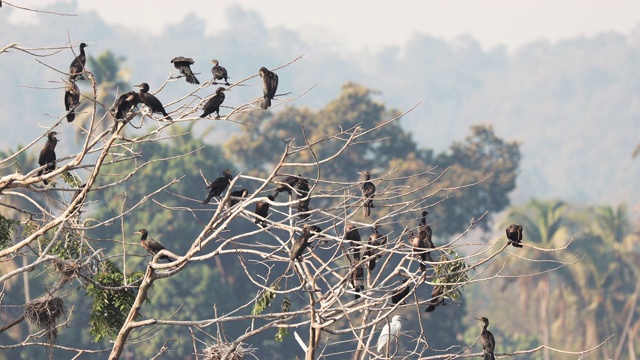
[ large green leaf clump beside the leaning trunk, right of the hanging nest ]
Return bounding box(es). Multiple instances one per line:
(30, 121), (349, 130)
(86, 260), (144, 342)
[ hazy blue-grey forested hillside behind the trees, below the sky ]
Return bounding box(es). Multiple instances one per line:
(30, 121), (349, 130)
(0, 3), (640, 206)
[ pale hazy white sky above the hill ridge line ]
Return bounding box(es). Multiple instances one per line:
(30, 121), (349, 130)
(9, 0), (640, 50)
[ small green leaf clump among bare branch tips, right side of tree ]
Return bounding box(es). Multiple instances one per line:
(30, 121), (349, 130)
(433, 250), (469, 300)
